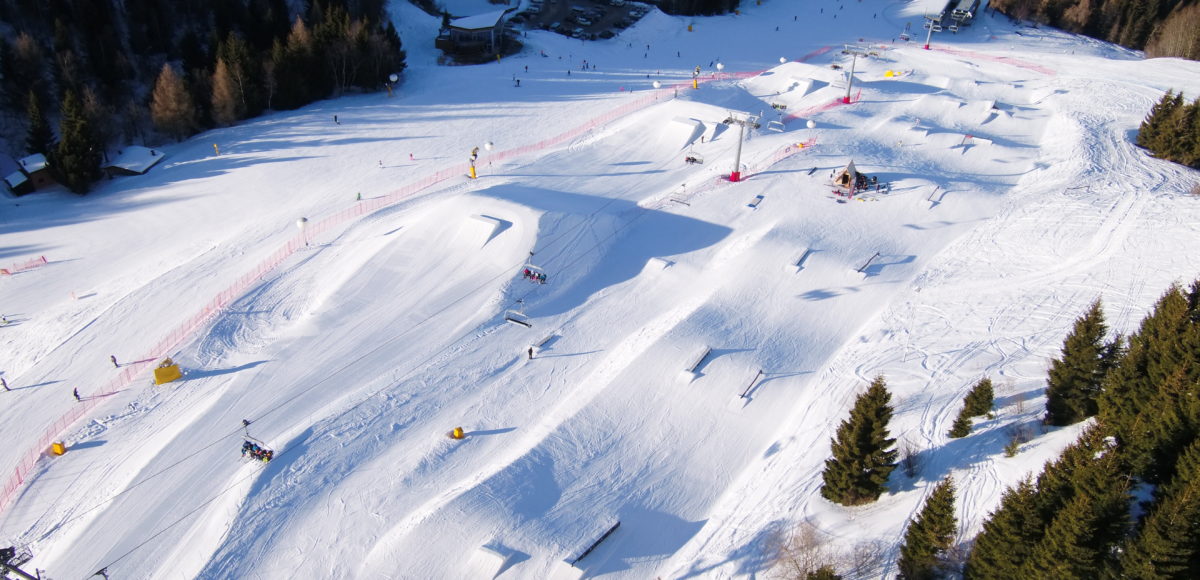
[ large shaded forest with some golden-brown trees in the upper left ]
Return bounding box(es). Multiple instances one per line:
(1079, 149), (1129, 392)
(0, 0), (404, 193)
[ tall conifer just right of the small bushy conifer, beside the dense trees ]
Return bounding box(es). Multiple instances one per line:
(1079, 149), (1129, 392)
(1046, 300), (1110, 425)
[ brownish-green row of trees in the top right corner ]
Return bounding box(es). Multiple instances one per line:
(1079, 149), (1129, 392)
(988, 0), (1200, 60)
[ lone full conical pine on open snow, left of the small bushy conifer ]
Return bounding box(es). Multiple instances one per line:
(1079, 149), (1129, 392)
(821, 377), (896, 506)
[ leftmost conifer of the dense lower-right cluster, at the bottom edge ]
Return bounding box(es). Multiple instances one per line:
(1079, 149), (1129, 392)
(962, 479), (1045, 580)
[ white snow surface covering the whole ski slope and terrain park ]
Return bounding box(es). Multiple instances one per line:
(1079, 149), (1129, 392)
(0, 0), (1200, 579)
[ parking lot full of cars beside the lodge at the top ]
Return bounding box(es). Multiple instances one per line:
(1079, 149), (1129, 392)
(510, 0), (647, 40)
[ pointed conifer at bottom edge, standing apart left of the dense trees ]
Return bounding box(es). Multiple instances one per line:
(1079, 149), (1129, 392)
(896, 477), (959, 580)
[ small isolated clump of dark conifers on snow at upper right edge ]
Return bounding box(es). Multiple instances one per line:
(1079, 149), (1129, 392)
(1138, 91), (1200, 169)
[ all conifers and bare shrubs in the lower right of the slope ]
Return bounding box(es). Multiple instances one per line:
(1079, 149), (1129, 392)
(773, 281), (1200, 580)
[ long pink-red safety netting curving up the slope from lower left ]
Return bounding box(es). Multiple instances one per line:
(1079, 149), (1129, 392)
(0, 47), (829, 512)
